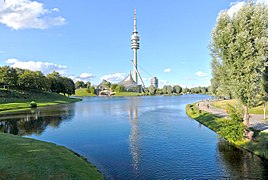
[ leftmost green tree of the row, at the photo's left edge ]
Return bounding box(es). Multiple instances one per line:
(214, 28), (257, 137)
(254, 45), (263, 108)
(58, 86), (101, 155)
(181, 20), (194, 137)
(0, 66), (18, 88)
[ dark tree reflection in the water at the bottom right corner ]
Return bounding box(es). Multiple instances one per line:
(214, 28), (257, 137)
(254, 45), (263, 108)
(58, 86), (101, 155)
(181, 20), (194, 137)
(218, 140), (268, 179)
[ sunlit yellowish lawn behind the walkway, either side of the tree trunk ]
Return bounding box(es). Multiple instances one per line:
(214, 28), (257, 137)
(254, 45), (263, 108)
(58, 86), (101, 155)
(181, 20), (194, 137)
(212, 99), (268, 114)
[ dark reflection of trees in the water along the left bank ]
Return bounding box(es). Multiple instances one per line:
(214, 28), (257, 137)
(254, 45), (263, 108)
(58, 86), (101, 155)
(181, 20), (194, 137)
(0, 106), (74, 136)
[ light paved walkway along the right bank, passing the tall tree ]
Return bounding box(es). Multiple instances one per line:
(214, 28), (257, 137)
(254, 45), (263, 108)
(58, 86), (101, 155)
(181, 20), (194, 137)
(197, 101), (268, 132)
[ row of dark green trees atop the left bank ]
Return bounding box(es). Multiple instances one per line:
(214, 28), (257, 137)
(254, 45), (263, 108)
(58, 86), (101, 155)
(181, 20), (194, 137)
(0, 66), (75, 95)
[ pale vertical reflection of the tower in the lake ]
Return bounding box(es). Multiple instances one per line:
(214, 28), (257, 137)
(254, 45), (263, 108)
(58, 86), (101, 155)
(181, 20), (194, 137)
(128, 101), (140, 171)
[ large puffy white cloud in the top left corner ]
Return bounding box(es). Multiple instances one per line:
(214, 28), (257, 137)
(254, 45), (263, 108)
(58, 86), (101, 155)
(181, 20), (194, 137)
(0, 0), (65, 30)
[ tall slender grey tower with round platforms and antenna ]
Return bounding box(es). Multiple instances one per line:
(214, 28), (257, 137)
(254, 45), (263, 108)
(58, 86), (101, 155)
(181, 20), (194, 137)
(131, 9), (140, 84)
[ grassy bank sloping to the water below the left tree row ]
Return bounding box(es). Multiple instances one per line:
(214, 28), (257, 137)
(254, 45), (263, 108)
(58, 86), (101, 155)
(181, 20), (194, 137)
(0, 89), (80, 113)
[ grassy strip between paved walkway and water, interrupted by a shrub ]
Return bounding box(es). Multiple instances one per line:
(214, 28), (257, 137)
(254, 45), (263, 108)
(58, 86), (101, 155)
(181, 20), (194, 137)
(186, 104), (268, 159)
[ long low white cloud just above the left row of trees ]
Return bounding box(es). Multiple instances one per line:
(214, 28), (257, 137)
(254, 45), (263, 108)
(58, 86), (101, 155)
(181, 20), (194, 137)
(6, 59), (67, 74)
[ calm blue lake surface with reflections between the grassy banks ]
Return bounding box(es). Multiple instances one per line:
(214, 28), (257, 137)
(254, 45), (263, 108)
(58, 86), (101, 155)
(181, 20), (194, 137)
(0, 95), (268, 179)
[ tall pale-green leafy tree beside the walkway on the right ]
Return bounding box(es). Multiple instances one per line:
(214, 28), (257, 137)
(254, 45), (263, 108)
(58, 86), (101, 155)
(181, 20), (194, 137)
(211, 2), (268, 124)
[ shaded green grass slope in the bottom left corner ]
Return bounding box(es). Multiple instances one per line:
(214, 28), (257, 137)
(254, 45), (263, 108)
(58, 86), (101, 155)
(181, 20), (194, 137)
(0, 133), (103, 180)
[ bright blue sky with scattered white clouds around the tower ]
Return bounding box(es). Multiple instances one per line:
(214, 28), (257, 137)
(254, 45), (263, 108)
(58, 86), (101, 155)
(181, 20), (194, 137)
(0, 0), (268, 87)
